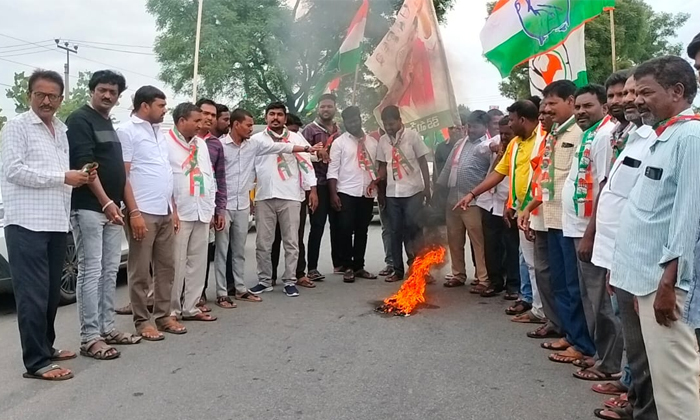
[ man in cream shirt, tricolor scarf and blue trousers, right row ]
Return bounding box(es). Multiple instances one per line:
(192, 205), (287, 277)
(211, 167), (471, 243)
(518, 80), (595, 363)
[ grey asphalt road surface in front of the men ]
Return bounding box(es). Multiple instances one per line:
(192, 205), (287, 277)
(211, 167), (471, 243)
(0, 225), (603, 420)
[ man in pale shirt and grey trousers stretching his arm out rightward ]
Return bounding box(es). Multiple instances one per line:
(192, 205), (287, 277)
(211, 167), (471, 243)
(214, 108), (323, 309)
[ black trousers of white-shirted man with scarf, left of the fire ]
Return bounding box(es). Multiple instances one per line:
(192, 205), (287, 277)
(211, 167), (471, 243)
(337, 193), (374, 271)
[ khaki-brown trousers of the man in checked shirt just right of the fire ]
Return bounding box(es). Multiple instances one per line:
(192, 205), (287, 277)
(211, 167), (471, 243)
(446, 206), (489, 285)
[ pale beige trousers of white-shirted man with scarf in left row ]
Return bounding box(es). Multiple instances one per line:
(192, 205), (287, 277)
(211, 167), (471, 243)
(170, 221), (209, 317)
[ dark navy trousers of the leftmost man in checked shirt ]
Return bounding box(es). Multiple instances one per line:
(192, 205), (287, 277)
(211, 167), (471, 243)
(5, 225), (68, 373)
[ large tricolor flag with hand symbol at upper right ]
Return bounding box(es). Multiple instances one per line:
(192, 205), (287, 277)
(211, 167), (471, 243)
(481, 0), (615, 77)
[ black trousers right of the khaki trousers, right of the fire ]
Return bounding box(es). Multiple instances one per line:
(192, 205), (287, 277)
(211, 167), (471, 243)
(481, 209), (520, 293)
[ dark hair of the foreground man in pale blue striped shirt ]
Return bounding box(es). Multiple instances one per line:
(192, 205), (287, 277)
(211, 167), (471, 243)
(634, 55), (698, 102)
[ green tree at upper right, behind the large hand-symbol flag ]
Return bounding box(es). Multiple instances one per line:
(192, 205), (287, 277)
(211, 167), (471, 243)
(486, 0), (690, 100)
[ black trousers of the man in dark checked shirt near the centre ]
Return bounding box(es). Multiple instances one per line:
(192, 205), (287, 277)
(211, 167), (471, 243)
(308, 185), (341, 271)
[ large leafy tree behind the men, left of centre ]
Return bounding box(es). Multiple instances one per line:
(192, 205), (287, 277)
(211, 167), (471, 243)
(146, 0), (455, 116)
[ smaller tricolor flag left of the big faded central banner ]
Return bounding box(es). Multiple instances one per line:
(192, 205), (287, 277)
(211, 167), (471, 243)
(304, 0), (369, 111)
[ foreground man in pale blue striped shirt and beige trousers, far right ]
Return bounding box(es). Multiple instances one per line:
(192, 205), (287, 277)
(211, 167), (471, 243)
(610, 56), (700, 420)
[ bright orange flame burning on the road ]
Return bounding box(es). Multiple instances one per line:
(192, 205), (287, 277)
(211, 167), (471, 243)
(378, 246), (445, 315)
